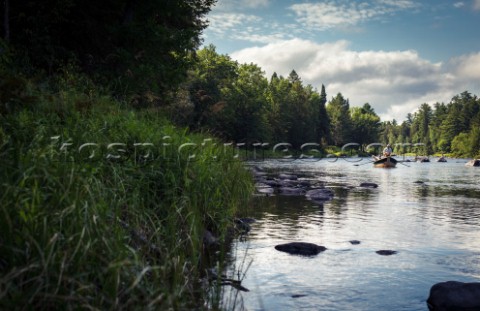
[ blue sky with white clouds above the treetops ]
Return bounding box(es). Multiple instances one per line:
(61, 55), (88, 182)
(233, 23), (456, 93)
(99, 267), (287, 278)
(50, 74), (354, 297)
(203, 0), (480, 122)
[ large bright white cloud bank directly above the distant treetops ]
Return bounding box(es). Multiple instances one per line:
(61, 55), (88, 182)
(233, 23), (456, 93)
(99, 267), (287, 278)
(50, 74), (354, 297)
(231, 39), (480, 121)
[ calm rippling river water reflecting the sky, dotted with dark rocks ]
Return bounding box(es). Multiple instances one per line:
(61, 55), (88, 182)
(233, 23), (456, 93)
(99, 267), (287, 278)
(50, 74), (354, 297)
(224, 159), (480, 311)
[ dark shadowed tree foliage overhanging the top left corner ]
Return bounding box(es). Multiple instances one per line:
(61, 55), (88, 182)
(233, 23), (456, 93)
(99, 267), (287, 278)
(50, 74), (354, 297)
(2, 0), (215, 96)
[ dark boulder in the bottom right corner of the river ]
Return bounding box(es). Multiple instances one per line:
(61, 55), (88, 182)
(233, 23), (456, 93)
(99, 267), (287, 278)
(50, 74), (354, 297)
(427, 281), (480, 311)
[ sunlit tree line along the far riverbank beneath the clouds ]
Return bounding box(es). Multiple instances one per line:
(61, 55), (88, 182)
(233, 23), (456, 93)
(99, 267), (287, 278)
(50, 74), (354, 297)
(169, 45), (480, 156)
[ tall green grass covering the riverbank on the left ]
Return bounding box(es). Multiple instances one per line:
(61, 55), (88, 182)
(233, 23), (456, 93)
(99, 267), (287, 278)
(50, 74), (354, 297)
(0, 72), (251, 310)
